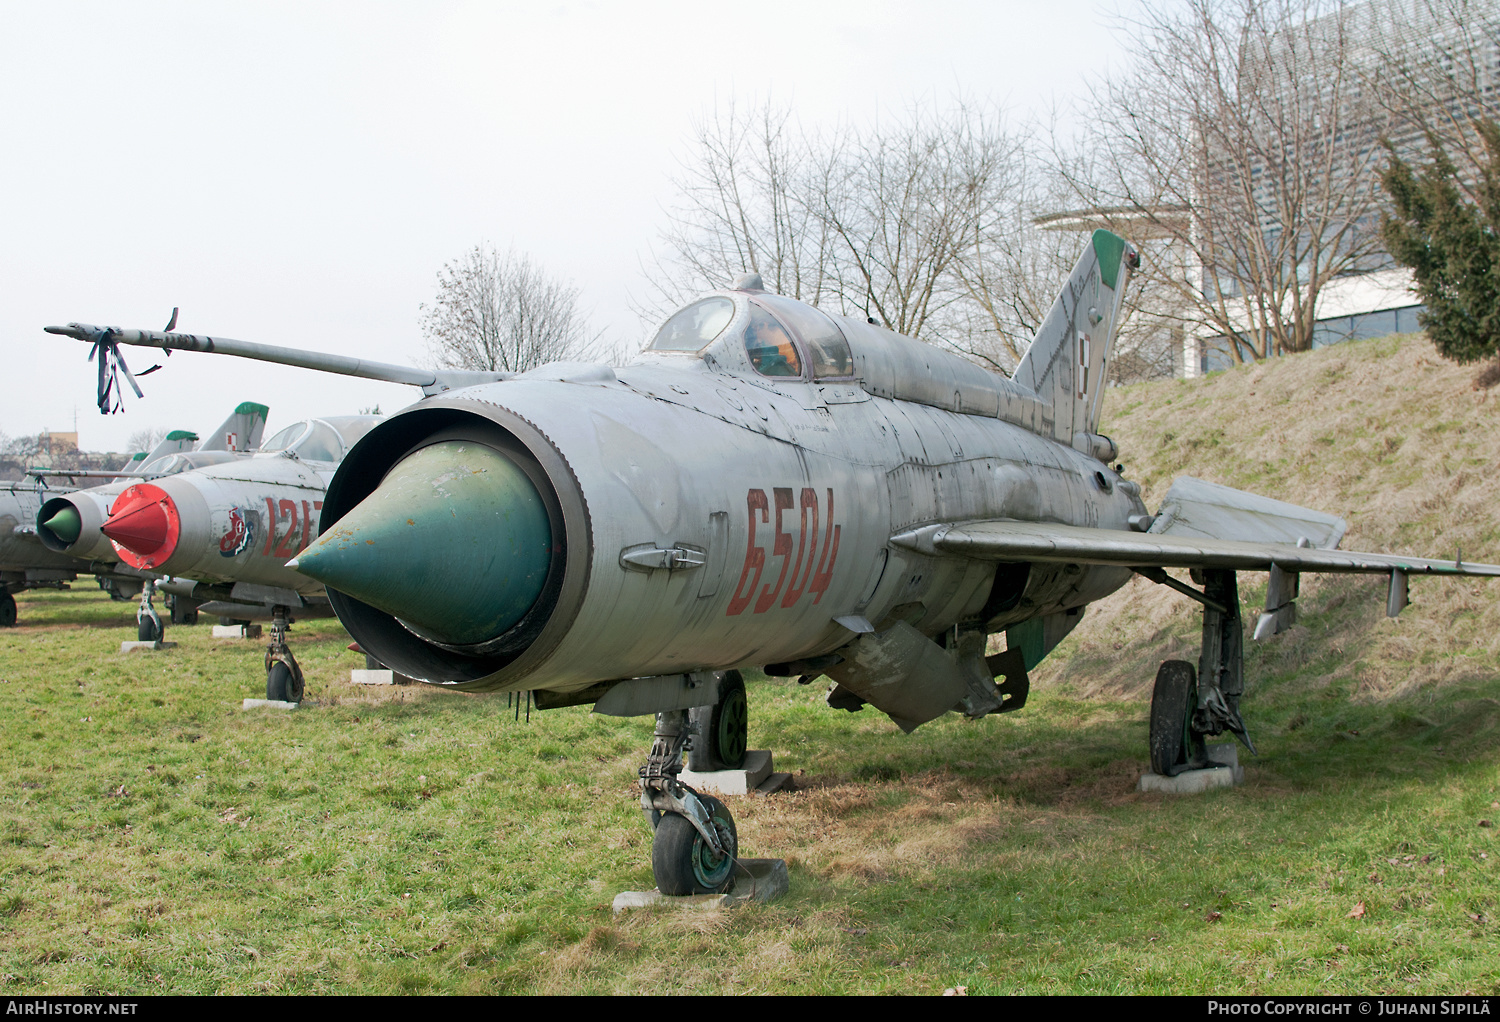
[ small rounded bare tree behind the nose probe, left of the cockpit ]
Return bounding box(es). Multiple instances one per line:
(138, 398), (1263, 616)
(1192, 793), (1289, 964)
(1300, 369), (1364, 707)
(419, 245), (602, 372)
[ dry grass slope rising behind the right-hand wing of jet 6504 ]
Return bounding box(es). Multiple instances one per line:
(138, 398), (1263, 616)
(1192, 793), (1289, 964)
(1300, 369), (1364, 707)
(1040, 335), (1500, 698)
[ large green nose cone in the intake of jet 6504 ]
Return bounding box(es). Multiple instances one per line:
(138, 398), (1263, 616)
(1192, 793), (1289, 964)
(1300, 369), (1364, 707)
(296, 441), (552, 645)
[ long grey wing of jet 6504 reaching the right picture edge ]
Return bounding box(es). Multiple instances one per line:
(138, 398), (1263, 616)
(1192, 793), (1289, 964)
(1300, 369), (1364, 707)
(891, 521), (1500, 576)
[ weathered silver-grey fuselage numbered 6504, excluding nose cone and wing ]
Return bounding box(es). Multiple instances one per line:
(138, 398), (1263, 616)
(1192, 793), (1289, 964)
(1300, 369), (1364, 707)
(310, 291), (1145, 692)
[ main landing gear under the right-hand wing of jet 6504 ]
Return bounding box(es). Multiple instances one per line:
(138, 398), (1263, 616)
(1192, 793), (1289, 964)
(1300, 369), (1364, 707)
(1140, 569), (1256, 777)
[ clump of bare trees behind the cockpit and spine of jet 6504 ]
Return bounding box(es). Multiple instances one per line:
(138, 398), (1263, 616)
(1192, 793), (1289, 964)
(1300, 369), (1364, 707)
(642, 95), (1044, 369)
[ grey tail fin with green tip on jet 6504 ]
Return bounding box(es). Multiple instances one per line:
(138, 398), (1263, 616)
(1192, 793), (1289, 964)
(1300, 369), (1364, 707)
(1013, 230), (1140, 452)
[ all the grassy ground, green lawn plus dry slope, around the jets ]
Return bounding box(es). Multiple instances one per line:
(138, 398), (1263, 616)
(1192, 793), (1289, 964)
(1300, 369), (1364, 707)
(0, 339), (1500, 993)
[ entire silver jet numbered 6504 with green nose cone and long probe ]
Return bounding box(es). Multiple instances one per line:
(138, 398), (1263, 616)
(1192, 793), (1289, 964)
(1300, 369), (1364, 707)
(48, 231), (1500, 894)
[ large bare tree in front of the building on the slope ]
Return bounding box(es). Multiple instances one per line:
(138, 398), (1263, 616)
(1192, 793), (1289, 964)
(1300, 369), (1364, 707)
(1061, 0), (1391, 362)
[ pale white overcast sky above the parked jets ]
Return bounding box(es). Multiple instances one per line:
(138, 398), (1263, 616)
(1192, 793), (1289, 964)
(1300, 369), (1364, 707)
(0, 0), (1121, 450)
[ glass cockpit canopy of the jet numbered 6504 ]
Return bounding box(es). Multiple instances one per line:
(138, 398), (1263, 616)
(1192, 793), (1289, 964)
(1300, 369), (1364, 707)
(647, 293), (854, 380)
